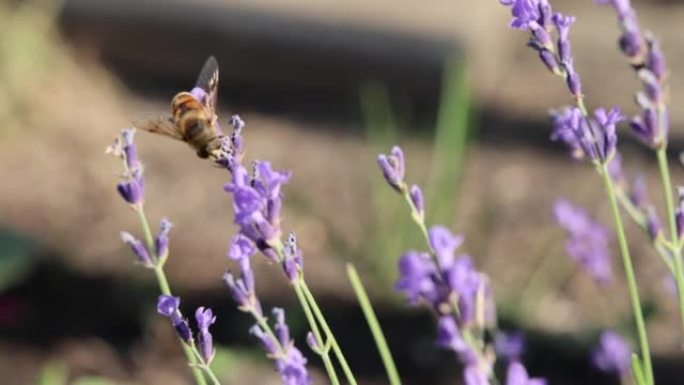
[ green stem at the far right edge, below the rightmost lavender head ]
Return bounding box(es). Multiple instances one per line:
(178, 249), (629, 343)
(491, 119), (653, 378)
(656, 146), (684, 336)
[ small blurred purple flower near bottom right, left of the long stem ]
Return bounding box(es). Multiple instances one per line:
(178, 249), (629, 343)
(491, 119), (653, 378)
(591, 330), (632, 376)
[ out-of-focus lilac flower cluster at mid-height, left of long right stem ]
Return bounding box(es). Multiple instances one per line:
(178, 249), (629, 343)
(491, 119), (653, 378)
(553, 199), (613, 284)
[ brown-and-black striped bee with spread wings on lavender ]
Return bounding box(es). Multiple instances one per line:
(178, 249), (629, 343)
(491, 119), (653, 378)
(133, 56), (224, 159)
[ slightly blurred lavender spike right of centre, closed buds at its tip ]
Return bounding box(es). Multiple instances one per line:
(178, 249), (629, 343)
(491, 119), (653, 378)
(378, 146), (546, 385)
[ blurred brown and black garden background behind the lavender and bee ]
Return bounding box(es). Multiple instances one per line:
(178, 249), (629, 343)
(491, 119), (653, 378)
(0, 0), (684, 384)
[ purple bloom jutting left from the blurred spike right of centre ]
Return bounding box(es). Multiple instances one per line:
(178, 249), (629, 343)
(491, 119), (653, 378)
(396, 250), (443, 304)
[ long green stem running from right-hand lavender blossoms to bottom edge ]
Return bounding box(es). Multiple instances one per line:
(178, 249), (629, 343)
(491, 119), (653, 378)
(600, 164), (653, 385)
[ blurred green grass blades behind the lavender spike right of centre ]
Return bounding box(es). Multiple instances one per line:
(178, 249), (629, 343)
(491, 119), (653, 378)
(361, 57), (471, 288)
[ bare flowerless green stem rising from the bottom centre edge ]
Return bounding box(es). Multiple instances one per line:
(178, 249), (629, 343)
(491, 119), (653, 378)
(347, 263), (401, 385)
